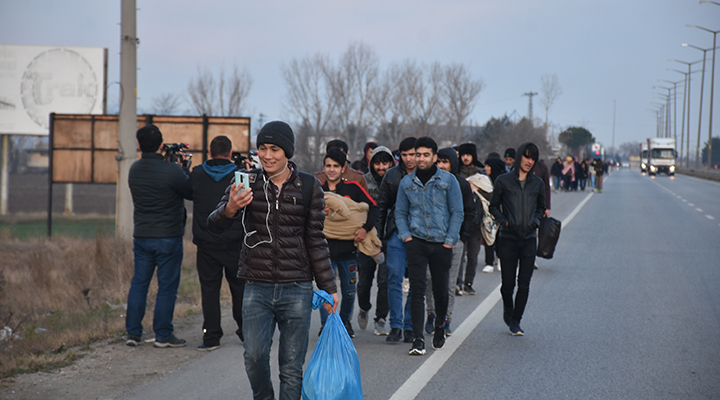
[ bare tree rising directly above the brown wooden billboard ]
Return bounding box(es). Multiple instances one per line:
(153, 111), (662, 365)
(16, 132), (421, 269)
(188, 65), (253, 117)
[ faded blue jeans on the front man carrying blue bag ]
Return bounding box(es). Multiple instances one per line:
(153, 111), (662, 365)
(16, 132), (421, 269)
(243, 281), (313, 400)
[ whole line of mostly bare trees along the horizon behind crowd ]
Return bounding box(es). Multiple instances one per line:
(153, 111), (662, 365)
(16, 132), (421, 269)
(148, 42), (594, 169)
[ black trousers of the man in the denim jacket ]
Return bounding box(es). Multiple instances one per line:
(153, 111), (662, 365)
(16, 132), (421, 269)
(405, 237), (452, 338)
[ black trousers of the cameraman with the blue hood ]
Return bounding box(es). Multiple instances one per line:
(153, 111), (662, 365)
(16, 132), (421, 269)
(197, 247), (245, 346)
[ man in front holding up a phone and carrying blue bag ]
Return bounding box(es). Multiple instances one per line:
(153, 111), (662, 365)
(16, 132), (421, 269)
(208, 121), (338, 400)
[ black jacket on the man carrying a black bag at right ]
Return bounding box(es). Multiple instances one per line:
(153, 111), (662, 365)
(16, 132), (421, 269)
(489, 146), (545, 239)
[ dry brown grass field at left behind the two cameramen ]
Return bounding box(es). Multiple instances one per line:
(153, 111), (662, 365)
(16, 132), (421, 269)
(0, 217), (204, 377)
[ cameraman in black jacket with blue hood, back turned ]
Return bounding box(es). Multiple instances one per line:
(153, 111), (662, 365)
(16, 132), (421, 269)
(190, 136), (245, 351)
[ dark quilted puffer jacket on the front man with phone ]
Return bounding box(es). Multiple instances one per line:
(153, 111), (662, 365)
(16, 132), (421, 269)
(208, 162), (337, 293)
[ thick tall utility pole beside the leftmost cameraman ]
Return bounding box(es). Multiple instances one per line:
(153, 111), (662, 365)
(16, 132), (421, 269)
(115, 0), (138, 240)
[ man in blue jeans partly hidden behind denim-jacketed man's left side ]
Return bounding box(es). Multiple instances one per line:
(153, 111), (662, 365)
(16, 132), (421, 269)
(376, 137), (425, 343)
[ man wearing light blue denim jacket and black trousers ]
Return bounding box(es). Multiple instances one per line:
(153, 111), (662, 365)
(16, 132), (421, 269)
(395, 137), (464, 355)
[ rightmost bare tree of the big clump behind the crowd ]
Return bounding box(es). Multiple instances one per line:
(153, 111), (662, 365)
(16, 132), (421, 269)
(442, 64), (483, 143)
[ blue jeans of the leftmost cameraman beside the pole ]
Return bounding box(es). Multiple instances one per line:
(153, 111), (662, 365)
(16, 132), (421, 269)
(125, 236), (183, 340)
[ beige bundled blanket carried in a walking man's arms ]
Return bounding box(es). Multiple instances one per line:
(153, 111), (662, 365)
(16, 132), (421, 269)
(323, 192), (385, 263)
